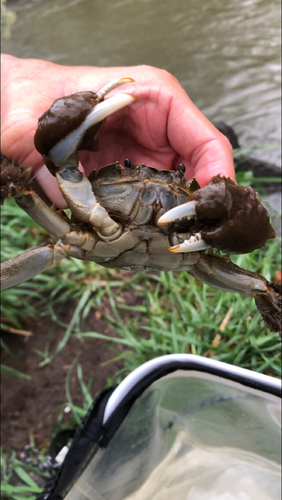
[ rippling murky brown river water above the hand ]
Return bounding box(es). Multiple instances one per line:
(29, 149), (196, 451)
(2, 0), (281, 165)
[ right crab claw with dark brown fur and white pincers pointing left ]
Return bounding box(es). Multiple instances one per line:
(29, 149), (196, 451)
(158, 175), (275, 253)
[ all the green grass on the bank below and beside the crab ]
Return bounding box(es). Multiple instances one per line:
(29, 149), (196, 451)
(1, 178), (281, 500)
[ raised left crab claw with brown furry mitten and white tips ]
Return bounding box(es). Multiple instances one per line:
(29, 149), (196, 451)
(34, 78), (134, 174)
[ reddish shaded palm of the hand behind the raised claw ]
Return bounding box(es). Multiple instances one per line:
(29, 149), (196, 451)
(80, 91), (187, 180)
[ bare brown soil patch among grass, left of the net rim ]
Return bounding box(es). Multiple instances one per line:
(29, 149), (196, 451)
(1, 305), (123, 451)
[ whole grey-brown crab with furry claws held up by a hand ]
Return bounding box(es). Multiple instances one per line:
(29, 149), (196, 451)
(1, 78), (281, 333)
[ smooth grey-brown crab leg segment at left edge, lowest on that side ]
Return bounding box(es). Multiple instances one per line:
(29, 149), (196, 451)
(1, 242), (68, 290)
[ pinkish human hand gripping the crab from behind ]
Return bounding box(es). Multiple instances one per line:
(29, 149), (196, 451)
(1, 54), (235, 206)
